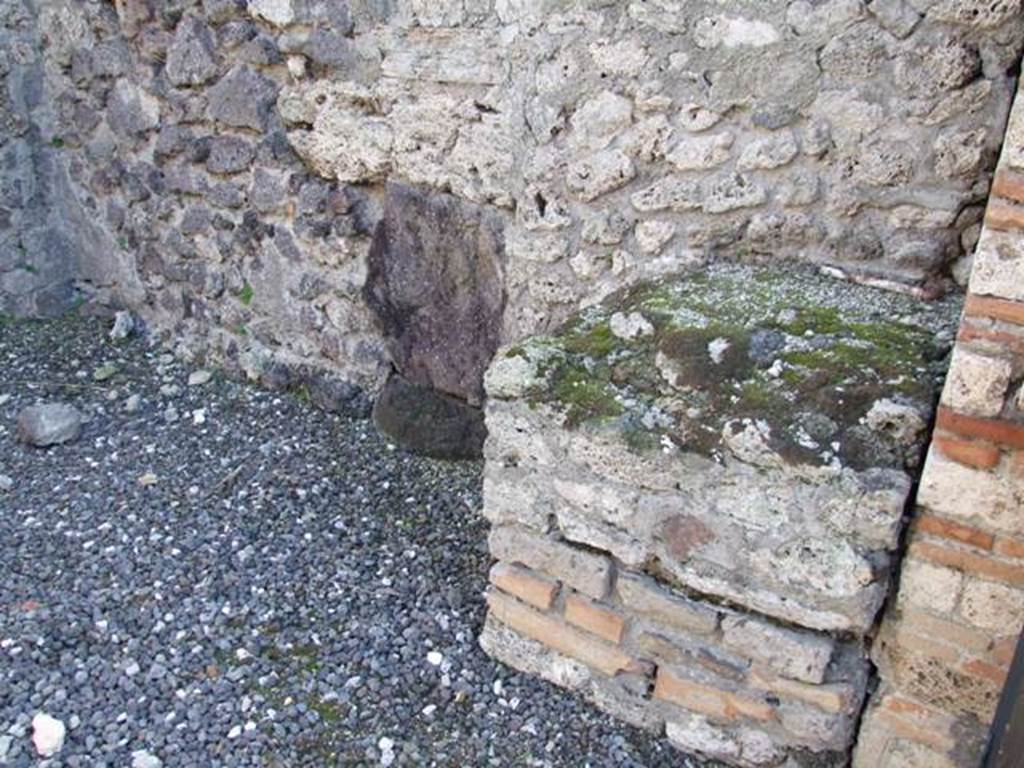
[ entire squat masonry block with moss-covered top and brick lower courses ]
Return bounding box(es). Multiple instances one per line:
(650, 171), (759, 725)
(480, 266), (958, 766)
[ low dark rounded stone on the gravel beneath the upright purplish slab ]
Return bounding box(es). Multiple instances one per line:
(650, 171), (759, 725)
(374, 374), (487, 459)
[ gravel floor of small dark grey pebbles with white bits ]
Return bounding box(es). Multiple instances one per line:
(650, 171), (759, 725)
(0, 318), (692, 768)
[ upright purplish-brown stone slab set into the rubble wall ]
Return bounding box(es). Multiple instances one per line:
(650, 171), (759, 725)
(364, 183), (505, 404)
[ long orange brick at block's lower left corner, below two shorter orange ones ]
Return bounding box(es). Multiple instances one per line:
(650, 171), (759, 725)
(487, 591), (647, 677)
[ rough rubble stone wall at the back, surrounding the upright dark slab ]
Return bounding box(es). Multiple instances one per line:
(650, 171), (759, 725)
(0, 0), (1024, 409)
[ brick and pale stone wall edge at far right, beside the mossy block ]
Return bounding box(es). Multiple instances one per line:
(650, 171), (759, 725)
(854, 70), (1024, 768)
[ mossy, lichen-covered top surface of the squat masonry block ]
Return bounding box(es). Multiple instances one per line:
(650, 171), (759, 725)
(504, 264), (958, 468)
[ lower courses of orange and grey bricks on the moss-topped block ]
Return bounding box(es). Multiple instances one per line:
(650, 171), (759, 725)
(480, 525), (867, 766)
